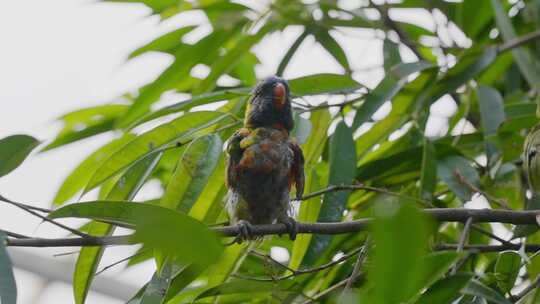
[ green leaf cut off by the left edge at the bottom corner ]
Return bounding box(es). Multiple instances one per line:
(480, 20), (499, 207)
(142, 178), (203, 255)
(0, 232), (17, 304)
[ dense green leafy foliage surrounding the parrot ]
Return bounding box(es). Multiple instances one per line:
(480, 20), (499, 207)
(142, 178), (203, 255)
(0, 0), (540, 304)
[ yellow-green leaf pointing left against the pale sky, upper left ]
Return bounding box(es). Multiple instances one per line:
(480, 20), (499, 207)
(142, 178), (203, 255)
(41, 104), (129, 152)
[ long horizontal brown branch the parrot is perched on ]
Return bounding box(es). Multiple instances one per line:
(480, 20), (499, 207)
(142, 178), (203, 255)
(6, 208), (540, 250)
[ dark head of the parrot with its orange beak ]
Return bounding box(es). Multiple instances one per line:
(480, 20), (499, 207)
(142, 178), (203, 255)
(244, 76), (294, 132)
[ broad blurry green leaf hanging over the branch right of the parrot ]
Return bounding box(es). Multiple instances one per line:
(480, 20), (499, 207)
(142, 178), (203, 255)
(368, 198), (429, 303)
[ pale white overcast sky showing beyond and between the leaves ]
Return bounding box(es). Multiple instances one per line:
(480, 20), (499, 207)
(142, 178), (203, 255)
(0, 0), (458, 304)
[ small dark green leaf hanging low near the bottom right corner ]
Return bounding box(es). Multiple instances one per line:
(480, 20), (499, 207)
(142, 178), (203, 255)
(495, 251), (521, 292)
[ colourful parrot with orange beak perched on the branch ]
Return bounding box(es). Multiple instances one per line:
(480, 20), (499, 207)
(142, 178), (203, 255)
(225, 76), (305, 243)
